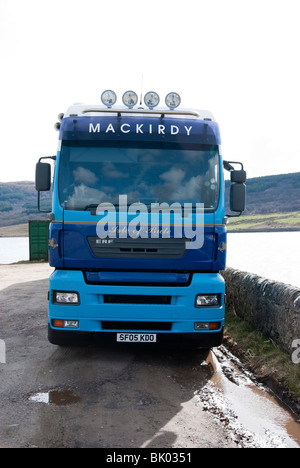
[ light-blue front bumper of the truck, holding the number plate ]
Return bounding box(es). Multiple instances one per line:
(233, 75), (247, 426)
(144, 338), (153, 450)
(49, 270), (225, 347)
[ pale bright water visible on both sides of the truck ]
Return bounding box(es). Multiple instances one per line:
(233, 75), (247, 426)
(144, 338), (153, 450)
(0, 231), (300, 287)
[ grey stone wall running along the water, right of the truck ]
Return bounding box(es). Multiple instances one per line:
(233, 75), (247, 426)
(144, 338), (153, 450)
(222, 268), (300, 354)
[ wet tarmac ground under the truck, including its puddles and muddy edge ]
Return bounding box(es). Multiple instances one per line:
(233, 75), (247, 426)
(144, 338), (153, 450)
(0, 265), (300, 448)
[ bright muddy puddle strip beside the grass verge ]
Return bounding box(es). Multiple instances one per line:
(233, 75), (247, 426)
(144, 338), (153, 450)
(198, 347), (300, 448)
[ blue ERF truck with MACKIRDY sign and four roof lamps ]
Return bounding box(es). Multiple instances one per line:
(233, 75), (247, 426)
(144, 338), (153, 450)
(36, 90), (246, 348)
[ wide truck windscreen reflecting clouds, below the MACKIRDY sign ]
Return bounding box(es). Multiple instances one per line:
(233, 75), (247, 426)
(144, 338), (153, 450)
(59, 141), (219, 211)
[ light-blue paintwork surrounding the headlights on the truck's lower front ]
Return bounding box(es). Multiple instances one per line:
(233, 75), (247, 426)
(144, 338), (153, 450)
(49, 270), (225, 333)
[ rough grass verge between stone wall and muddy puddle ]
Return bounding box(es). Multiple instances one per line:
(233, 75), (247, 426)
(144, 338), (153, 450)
(224, 309), (300, 417)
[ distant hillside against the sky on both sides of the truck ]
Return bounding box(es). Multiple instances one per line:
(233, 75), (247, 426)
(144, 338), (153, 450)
(0, 172), (300, 227)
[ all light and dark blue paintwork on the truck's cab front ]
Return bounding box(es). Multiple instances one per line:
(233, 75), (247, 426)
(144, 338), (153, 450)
(49, 109), (226, 344)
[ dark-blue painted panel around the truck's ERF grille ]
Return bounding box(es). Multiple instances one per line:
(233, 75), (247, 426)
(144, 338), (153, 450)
(49, 222), (226, 271)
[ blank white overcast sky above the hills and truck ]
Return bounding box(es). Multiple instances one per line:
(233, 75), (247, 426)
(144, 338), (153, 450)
(0, 0), (300, 182)
